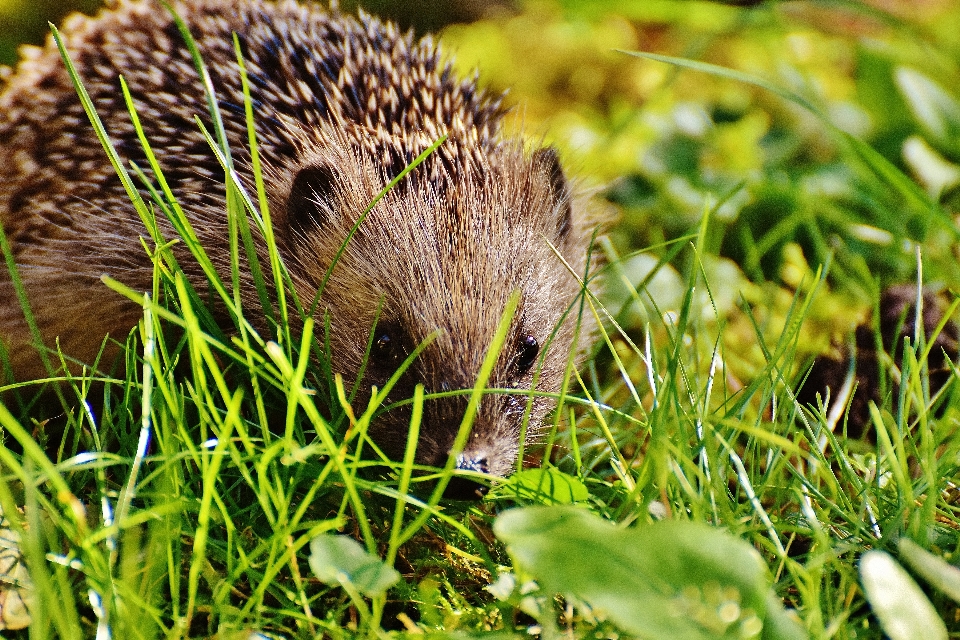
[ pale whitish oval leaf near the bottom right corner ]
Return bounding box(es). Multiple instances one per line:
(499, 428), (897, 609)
(860, 551), (947, 640)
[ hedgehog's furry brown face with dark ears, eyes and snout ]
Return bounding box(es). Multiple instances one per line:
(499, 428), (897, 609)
(272, 138), (587, 492)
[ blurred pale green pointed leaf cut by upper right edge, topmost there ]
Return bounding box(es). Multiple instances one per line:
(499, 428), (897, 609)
(894, 67), (960, 153)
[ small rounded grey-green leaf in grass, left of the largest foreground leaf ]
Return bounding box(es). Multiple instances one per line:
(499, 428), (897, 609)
(310, 534), (400, 596)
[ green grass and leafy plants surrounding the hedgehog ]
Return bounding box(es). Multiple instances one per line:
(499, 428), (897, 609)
(0, 0), (960, 639)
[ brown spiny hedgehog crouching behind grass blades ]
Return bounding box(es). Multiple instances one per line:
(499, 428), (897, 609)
(0, 0), (595, 484)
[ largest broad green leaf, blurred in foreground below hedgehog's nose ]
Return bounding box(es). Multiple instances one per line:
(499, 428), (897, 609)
(494, 506), (806, 640)
